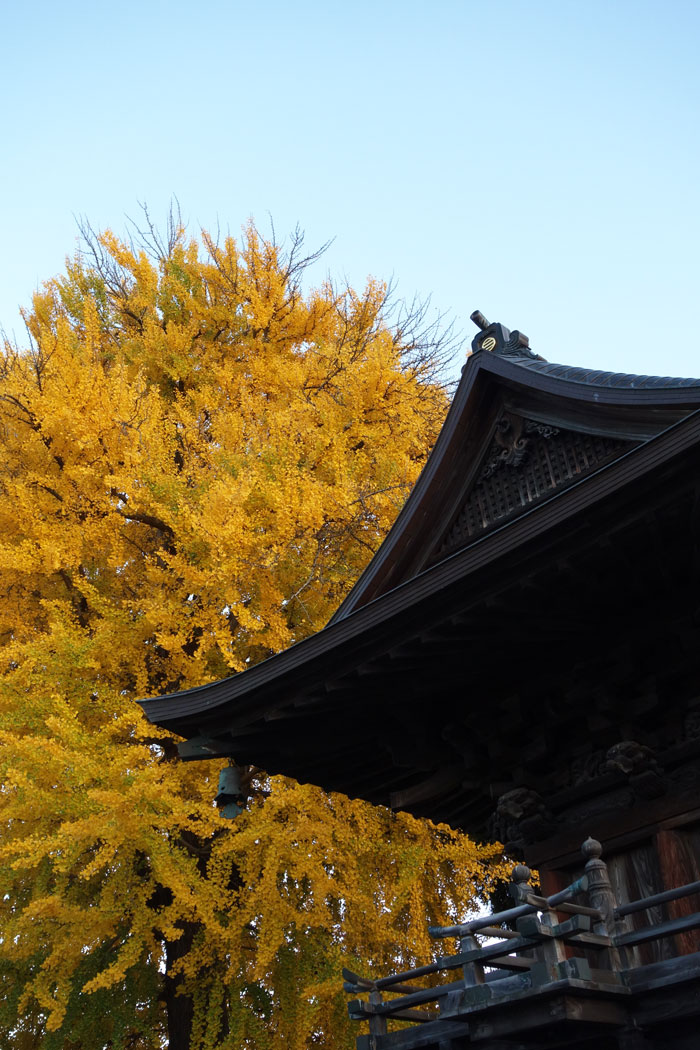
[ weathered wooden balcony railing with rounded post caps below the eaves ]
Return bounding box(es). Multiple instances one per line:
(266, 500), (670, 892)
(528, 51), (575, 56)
(343, 839), (700, 1036)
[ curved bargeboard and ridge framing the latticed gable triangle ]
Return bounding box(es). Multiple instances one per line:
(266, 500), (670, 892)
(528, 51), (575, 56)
(332, 324), (700, 623)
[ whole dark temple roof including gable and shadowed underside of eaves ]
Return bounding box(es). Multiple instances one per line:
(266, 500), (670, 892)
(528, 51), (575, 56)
(142, 317), (700, 831)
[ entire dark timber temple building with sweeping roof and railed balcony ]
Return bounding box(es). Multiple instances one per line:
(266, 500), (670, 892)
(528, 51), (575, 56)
(139, 315), (700, 1050)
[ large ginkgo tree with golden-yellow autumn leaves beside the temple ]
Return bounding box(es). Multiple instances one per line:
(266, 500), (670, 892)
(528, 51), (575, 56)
(0, 213), (501, 1050)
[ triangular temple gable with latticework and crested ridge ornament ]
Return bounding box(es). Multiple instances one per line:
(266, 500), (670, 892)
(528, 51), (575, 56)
(331, 315), (700, 623)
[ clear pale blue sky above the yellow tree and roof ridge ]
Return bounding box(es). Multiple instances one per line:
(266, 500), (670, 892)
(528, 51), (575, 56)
(0, 0), (700, 376)
